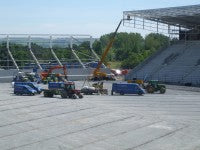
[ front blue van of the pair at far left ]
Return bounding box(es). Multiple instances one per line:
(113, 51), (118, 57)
(14, 84), (37, 95)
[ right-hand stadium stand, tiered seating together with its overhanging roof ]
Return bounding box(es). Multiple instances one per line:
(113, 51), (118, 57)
(124, 5), (200, 86)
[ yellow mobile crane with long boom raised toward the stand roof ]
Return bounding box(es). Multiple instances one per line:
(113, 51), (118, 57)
(91, 20), (123, 81)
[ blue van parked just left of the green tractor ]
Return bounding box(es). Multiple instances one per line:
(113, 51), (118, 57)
(111, 83), (145, 95)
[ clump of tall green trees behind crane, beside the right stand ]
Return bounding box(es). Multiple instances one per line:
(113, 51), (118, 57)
(93, 32), (169, 69)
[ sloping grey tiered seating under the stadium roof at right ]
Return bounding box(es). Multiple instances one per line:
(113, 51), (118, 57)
(126, 41), (200, 85)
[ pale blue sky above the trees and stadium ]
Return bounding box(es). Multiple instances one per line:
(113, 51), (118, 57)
(0, 0), (200, 37)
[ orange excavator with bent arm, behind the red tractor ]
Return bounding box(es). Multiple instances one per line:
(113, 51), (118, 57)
(40, 66), (67, 80)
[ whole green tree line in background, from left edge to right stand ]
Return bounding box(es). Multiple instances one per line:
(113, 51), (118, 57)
(0, 32), (169, 69)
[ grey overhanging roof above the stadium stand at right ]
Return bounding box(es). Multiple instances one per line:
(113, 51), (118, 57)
(124, 5), (200, 28)
